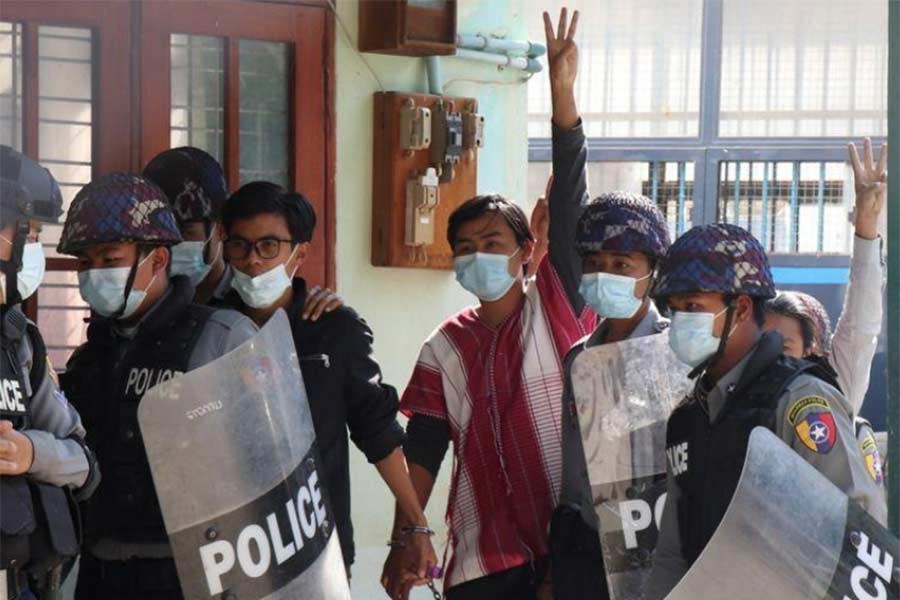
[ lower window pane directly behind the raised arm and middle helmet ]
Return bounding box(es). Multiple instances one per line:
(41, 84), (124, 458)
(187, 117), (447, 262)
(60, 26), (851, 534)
(527, 161), (694, 240)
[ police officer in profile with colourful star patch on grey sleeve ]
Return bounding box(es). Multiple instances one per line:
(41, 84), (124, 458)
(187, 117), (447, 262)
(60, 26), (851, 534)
(647, 224), (887, 598)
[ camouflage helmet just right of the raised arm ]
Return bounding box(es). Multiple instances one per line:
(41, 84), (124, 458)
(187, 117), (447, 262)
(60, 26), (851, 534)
(575, 192), (671, 259)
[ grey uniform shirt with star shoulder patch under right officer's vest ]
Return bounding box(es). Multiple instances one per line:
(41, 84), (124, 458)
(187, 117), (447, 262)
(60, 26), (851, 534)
(645, 352), (887, 599)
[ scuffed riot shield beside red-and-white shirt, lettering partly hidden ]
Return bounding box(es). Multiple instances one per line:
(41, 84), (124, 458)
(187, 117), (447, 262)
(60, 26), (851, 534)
(571, 332), (691, 600)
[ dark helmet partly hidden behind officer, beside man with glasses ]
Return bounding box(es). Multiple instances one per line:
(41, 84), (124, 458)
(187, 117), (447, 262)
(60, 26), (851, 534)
(143, 146), (228, 223)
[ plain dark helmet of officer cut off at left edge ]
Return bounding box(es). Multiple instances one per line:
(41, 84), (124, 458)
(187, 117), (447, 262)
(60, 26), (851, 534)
(0, 145), (62, 225)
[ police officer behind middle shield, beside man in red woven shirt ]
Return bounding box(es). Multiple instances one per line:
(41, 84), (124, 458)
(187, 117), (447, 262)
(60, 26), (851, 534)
(550, 193), (670, 599)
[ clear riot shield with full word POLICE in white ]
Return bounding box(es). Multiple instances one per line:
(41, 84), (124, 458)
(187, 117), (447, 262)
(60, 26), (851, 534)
(138, 310), (350, 600)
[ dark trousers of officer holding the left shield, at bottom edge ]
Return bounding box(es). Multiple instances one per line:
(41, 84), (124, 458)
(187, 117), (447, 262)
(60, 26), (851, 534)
(75, 554), (183, 600)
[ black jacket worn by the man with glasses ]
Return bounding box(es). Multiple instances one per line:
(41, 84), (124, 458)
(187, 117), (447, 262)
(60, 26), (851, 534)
(227, 278), (403, 565)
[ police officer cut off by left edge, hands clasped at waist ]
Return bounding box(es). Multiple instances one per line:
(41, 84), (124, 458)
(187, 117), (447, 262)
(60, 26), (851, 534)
(0, 146), (100, 599)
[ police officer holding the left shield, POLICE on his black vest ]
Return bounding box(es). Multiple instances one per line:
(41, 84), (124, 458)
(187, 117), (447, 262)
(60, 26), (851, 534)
(58, 173), (256, 599)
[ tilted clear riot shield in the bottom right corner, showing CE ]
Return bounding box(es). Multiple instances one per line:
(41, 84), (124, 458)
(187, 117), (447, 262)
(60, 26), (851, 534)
(667, 427), (900, 600)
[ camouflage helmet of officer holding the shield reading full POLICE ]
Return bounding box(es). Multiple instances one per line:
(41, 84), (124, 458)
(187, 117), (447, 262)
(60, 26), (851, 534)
(57, 173), (181, 254)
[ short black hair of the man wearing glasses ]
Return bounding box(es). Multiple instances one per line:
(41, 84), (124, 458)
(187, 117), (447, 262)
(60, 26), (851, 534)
(222, 181), (316, 243)
